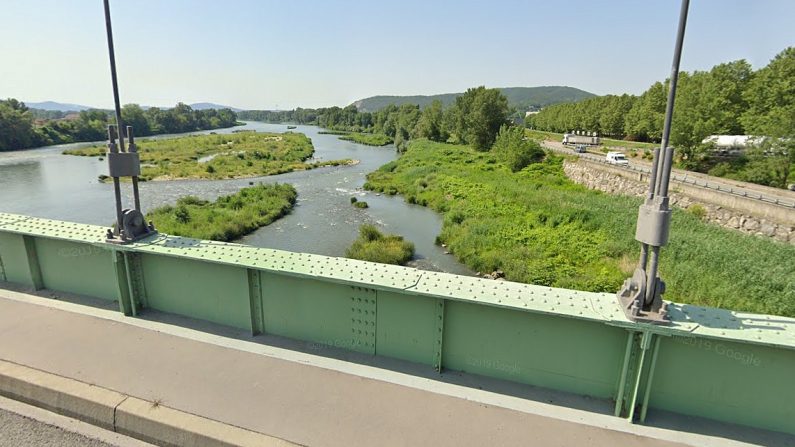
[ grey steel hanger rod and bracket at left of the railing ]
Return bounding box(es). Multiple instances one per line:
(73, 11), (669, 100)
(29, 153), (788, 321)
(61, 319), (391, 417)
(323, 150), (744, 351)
(104, 0), (157, 244)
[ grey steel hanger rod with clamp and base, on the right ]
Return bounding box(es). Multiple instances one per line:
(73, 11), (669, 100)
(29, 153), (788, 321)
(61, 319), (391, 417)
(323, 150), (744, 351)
(618, 0), (690, 324)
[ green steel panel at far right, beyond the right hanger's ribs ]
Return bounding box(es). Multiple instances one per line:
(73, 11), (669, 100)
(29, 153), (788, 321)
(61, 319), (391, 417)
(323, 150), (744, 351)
(649, 338), (795, 433)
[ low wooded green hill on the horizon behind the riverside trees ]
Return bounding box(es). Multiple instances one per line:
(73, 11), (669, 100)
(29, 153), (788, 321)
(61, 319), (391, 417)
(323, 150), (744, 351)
(353, 86), (596, 112)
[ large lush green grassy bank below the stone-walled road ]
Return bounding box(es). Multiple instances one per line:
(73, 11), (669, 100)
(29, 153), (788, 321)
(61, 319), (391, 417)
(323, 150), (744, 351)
(365, 140), (795, 317)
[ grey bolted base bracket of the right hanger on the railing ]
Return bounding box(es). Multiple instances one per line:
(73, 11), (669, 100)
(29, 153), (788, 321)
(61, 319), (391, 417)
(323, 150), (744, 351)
(617, 269), (671, 324)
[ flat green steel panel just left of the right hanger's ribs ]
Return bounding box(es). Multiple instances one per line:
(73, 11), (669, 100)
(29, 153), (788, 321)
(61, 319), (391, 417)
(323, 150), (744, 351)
(442, 302), (626, 398)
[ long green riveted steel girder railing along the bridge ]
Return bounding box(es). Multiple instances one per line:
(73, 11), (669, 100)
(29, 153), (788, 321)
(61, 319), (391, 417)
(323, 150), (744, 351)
(0, 213), (795, 434)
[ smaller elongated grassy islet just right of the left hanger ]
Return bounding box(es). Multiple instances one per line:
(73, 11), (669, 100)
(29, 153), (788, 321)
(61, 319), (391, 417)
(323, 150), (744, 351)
(146, 183), (297, 241)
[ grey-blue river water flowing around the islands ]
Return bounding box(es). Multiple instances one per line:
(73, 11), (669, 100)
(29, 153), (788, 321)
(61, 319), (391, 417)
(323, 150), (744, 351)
(0, 122), (472, 275)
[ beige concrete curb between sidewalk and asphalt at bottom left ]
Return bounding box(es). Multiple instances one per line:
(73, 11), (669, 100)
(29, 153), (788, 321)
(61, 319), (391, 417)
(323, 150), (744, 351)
(0, 360), (298, 447)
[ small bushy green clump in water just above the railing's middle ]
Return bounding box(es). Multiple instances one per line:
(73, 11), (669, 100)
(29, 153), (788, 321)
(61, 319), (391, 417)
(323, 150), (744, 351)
(345, 226), (414, 265)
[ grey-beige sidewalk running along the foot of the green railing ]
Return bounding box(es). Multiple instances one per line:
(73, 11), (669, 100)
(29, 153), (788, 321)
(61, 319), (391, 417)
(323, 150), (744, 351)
(0, 289), (778, 447)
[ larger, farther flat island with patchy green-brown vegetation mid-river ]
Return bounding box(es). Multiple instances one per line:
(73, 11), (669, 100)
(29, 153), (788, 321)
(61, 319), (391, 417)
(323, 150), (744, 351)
(63, 132), (356, 181)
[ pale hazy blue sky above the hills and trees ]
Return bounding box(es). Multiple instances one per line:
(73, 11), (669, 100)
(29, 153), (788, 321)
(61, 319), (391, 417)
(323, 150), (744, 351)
(0, 0), (795, 109)
